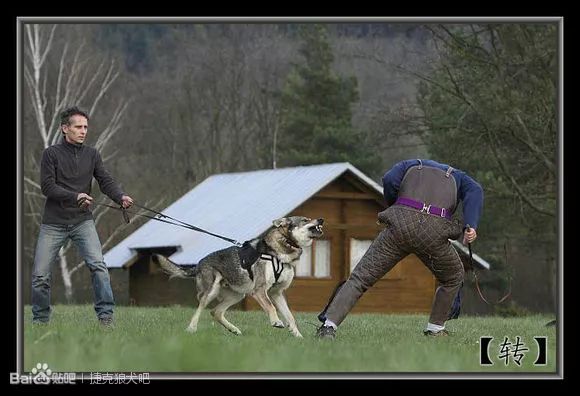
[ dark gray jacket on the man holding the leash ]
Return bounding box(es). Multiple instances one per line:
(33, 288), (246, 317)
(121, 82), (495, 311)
(40, 138), (125, 224)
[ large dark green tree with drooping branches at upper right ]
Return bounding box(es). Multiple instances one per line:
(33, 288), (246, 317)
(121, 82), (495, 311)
(424, 24), (558, 221)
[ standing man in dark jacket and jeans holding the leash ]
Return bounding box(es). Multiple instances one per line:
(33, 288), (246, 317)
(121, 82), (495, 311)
(32, 107), (133, 327)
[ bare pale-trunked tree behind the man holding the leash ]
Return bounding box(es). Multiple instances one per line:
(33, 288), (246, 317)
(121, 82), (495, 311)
(24, 24), (129, 301)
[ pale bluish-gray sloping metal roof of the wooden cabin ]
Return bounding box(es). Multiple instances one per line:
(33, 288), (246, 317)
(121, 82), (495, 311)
(105, 162), (383, 268)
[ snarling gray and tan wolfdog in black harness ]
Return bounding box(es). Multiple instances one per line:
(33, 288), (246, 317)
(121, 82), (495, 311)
(153, 216), (324, 337)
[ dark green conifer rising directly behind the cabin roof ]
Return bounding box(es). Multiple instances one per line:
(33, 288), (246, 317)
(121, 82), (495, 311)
(279, 25), (378, 171)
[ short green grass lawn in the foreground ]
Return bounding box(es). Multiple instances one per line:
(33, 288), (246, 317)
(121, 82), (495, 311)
(24, 305), (556, 374)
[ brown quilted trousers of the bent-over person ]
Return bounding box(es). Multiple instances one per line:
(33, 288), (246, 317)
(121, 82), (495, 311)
(326, 205), (464, 326)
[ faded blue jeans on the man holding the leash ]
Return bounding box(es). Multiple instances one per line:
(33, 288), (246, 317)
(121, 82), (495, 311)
(32, 220), (115, 322)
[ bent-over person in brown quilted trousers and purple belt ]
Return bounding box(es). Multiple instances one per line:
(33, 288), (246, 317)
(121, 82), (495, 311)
(317, 159), (483, 338)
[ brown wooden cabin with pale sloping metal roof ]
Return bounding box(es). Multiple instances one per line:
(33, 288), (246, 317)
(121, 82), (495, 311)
(105, 163), (484, 313)
